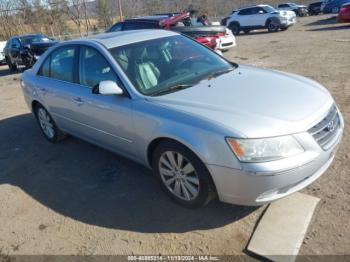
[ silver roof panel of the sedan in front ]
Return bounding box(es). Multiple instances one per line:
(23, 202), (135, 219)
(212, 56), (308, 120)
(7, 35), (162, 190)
(72, 29), (179, 49)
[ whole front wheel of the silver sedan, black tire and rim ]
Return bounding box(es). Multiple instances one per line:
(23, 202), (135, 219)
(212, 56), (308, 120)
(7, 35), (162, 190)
(152, 141), (216, 209)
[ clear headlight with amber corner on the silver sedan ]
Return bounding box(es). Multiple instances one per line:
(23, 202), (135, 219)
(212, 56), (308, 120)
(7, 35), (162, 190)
(226, 136), (304, 162)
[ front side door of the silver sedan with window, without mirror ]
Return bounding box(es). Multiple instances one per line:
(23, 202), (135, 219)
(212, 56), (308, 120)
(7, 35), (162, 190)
(73, 46), (134, 155)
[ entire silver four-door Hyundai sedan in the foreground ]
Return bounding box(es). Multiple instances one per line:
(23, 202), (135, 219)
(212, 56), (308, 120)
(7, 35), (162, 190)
(21, 30), (344, 208)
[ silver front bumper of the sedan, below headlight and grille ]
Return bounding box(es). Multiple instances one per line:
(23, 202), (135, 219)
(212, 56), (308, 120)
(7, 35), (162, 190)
(207, 109), (344, 206)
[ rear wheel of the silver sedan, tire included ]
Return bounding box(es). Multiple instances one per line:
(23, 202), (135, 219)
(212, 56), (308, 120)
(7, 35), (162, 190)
(35, 105), (66, 143)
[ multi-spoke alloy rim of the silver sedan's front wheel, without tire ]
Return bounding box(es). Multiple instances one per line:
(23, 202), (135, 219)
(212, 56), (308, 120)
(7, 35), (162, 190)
(158, 151), (200, 201)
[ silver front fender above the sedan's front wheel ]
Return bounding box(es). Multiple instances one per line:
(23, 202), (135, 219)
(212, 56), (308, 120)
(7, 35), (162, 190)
(134, 100), (240, 168)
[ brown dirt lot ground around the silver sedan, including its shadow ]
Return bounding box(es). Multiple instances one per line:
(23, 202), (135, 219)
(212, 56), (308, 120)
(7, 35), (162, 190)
(0, 13), (350, 255)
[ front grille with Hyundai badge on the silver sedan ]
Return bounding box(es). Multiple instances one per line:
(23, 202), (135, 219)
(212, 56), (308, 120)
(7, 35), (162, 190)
(309, 105), (340, 150)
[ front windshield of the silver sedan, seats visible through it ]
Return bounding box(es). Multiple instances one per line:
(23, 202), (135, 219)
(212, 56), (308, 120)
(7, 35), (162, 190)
(110, 35), (235, 96)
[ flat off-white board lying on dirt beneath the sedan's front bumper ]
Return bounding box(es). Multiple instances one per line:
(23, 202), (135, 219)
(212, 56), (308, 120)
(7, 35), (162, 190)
(247, 193), (320, 261)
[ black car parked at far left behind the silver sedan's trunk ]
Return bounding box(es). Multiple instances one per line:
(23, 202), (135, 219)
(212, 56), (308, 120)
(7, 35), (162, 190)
(4, 34), (58, 70)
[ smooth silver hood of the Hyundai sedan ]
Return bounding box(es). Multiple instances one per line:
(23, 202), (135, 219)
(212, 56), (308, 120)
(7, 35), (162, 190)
(147, 66), (334, 138)
